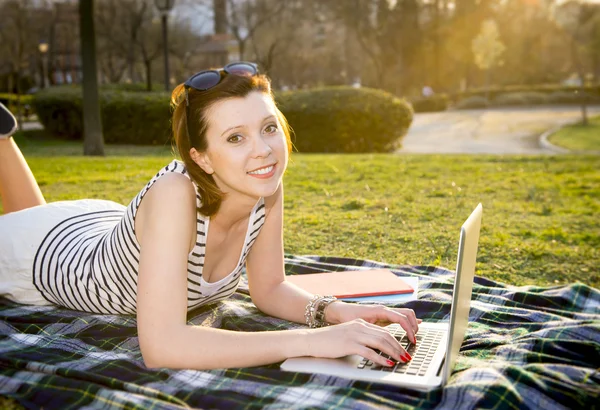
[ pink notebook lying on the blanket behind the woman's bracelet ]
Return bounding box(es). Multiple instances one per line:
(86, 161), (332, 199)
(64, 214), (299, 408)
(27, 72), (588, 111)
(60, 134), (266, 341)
(286, 269), (414, 298)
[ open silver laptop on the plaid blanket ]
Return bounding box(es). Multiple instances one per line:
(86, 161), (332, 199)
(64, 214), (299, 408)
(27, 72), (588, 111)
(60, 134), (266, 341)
(281, 204), (483, 391)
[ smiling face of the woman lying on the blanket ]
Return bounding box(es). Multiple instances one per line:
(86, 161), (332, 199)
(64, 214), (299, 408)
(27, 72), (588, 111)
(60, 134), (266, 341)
(191, 91), (288, 200)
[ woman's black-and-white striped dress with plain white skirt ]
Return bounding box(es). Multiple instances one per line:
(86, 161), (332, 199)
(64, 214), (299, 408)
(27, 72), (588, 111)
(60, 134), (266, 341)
(0, 160), (265, 314)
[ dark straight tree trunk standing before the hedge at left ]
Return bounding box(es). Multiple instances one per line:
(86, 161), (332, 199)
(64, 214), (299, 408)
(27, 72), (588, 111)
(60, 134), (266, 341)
(79, 0), (104, 155)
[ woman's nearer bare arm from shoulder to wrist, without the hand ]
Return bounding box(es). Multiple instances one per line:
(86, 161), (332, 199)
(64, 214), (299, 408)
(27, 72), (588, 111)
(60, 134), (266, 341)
(136, 174), (307, 369)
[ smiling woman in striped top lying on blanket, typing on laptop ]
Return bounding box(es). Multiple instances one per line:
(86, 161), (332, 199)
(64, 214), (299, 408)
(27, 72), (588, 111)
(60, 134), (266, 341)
(0, 62), (420, 369)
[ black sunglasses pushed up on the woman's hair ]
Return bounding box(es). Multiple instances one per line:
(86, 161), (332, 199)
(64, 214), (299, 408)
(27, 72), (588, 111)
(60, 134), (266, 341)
(183, 61), (258, 144)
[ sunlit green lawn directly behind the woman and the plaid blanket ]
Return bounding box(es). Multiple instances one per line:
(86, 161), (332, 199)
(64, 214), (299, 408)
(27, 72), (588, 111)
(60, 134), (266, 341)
(5, 134), (600, 287)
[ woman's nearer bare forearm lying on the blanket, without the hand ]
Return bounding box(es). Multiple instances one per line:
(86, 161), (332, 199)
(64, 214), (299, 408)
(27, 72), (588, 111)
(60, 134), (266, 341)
(142, 325), (310, 370)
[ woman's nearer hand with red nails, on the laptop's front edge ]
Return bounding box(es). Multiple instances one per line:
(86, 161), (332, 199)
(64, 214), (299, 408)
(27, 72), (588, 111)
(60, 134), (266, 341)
(307, 318), (411, 366)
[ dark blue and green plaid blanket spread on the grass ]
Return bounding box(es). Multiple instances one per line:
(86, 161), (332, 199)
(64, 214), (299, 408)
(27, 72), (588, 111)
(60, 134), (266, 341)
(0, 255), (600, 409)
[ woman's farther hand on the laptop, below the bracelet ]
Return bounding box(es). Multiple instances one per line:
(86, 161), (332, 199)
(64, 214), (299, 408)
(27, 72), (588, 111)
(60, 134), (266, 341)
(325, 301), (422, 343)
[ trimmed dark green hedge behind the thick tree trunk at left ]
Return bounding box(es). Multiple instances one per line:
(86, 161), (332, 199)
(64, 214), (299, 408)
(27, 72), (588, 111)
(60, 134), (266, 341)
(33, 87), (171, 145)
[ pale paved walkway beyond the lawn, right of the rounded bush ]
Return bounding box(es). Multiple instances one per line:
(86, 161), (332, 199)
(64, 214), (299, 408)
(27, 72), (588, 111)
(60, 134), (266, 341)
(398, 105), (600, 154)
